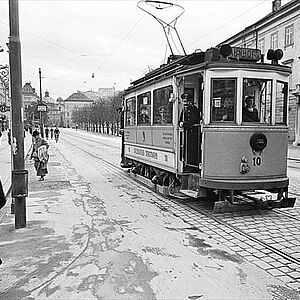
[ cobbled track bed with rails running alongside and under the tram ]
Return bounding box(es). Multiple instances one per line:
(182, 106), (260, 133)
(62, 133), (300, 285)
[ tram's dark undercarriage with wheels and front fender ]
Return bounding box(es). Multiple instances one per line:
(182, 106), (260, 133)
(121, 159), (296, 213)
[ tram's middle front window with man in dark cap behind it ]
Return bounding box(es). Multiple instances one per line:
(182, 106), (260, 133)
(242, 78), (272, 124)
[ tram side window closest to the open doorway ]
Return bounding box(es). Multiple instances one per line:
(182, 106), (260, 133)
(153, 85), (173, 125)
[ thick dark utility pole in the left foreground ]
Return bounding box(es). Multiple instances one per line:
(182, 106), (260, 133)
(9, 0), (28, 229)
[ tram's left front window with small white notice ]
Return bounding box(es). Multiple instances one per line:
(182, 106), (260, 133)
(211, 78), (236, 122)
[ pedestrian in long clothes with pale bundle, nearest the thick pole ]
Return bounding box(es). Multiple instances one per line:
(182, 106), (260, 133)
(30, 131), (49, 181)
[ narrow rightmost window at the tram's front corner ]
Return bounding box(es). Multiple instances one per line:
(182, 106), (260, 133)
(275, 81), (288, 125)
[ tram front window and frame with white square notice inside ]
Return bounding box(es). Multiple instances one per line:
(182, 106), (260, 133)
(210, 77), (237, 124)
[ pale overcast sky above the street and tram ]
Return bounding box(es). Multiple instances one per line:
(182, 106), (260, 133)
(0, 0), (289, 99)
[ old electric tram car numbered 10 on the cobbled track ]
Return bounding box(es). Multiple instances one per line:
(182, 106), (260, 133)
(121, 45), (295, 212)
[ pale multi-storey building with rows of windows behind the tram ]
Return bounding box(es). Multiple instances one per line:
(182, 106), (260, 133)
(220, 0), (300, 145)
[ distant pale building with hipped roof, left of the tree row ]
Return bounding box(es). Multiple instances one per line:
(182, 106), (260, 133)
(64, 91), (94, 127)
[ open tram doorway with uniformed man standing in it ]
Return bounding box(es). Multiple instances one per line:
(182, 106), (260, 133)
(179, 80), (203, 173)
